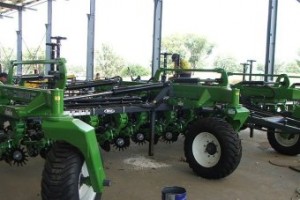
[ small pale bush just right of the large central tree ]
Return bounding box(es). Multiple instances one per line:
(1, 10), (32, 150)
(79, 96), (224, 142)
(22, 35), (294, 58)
(213, 56), (243, 72)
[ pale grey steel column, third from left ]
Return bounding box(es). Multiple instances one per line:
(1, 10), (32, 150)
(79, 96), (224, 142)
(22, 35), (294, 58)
(86, 0), (95, 80)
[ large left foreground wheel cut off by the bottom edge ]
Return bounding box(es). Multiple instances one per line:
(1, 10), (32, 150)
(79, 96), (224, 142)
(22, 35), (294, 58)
(42, 142), (101, 200)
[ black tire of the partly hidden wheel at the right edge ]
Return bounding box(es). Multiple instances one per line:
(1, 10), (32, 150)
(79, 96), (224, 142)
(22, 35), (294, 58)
(267, 129), (300, 156)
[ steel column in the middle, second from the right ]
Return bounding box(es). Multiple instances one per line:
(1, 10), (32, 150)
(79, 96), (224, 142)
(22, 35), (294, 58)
(152, 0), (163, 76)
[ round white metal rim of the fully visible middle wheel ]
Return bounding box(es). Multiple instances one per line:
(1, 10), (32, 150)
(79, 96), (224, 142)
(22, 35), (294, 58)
(192, 132), (221, 168)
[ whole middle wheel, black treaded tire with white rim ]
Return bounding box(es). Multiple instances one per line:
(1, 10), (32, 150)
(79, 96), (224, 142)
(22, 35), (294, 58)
(184, 117), (242, 179)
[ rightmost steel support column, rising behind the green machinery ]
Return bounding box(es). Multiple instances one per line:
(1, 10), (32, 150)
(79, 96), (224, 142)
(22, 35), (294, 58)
(264, 0), (278, 81)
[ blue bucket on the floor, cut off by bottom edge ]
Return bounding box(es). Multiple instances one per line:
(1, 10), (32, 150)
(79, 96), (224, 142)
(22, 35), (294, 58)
(161, 186), (187, 200)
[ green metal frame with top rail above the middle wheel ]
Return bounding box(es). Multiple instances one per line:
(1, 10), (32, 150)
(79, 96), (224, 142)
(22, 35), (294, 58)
(154, 68), (249, 131)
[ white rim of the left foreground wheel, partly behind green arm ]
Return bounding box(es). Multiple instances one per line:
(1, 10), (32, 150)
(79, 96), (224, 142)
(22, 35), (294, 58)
(78, 162), (96, 200)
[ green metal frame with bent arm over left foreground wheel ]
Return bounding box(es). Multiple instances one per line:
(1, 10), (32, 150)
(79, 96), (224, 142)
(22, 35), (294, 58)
(0, 59), (105, 192)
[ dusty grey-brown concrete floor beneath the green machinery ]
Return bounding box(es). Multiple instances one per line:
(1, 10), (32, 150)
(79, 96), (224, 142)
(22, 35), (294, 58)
(0, 130), (300, 200)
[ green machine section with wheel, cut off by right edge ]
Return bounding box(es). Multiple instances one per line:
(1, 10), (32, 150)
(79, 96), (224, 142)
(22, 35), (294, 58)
(231, 73), (300, 155)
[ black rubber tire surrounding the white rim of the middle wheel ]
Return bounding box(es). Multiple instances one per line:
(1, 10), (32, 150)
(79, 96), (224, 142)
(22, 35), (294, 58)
(184, 118), (242, 179)
